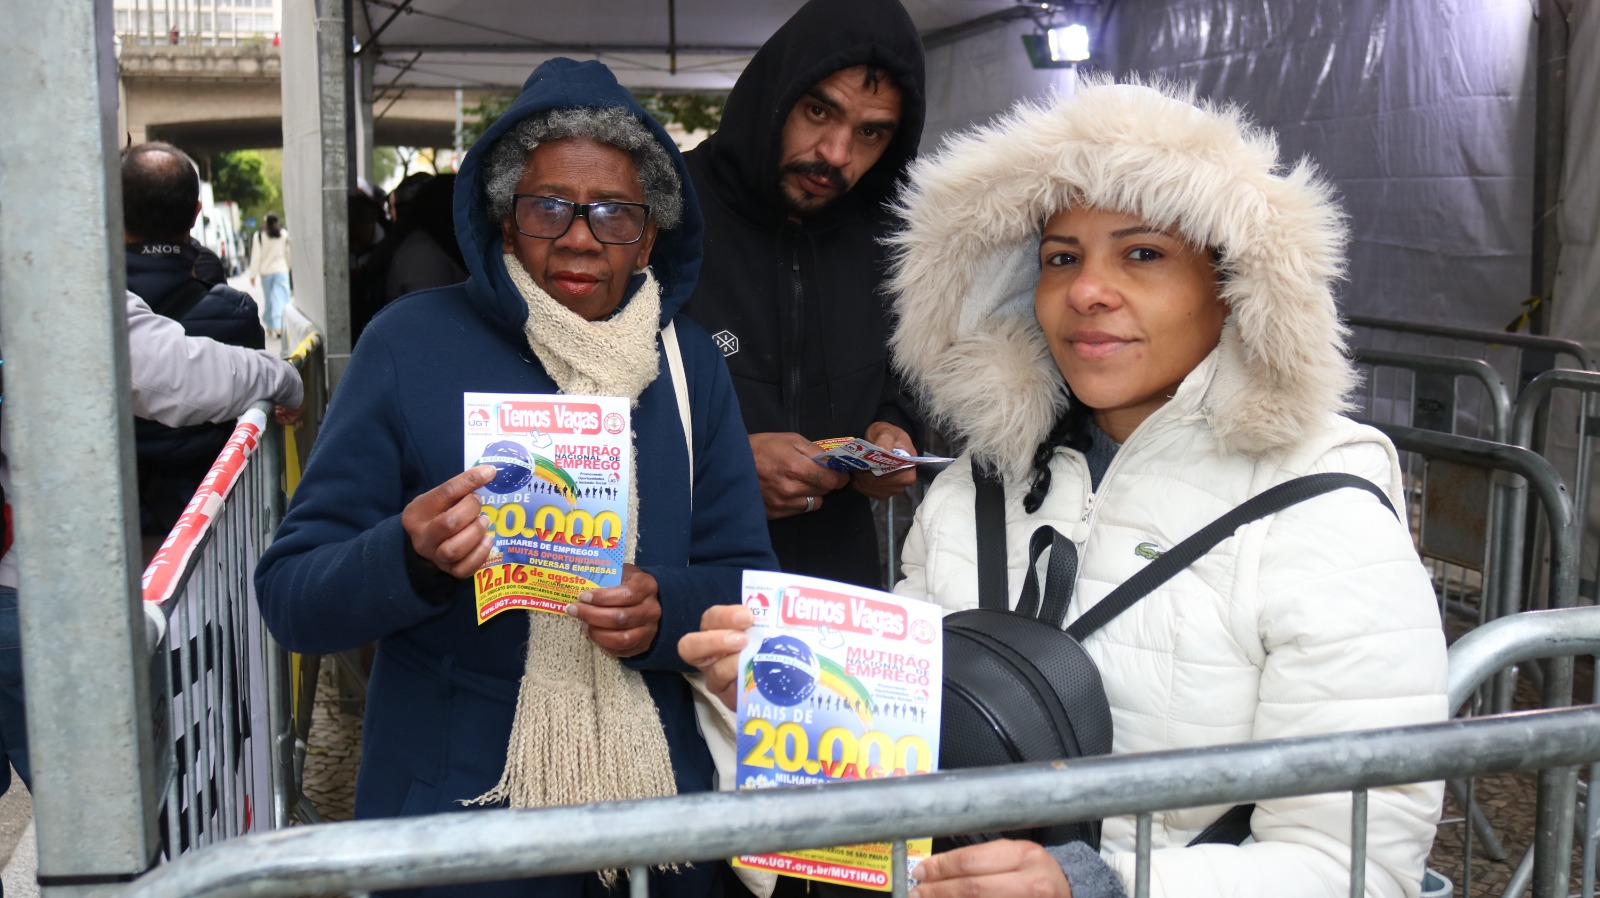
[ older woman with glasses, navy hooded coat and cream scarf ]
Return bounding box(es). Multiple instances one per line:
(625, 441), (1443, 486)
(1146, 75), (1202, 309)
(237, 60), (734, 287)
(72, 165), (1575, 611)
(256, 59), (776, 896)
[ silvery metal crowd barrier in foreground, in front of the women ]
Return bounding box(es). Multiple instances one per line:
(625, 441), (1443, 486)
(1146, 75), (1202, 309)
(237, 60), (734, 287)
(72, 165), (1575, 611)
(125, 608), (1600, 898)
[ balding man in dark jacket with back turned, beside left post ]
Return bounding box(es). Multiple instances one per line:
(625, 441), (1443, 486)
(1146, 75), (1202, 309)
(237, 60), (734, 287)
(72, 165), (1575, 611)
(122, 142), (266, 544)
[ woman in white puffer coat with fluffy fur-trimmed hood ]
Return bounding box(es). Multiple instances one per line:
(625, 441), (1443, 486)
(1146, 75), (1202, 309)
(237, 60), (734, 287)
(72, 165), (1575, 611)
(891, 82), (1446, 898)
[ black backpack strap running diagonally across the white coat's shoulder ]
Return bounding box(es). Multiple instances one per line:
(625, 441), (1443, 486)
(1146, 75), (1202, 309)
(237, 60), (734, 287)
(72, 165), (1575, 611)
(1067, 472), (1398, 642)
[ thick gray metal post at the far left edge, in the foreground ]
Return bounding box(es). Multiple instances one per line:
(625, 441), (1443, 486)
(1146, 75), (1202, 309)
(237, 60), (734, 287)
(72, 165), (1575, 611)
(0, 0), (158, 898)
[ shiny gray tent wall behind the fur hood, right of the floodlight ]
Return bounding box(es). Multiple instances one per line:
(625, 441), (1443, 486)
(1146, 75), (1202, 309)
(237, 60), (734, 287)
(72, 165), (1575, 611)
(1109, 0), (1534, 327)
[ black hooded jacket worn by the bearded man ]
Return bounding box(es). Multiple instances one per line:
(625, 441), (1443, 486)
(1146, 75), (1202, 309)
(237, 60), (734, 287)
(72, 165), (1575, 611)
(685, 0), (925, 586)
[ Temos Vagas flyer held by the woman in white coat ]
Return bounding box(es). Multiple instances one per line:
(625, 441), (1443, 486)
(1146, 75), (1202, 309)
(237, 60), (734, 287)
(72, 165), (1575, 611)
(733, 571), (944, 892)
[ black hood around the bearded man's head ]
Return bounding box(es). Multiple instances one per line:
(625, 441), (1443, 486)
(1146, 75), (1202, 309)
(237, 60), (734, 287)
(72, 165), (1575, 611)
(696, 0), (925, 226)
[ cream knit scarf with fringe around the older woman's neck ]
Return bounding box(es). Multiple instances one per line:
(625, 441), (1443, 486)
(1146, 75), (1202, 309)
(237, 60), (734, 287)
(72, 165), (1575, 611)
(475, 253), (677, 825)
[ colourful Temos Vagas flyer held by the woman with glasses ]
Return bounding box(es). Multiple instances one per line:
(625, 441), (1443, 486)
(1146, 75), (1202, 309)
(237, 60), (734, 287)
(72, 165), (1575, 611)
(462, 392), (632, 624)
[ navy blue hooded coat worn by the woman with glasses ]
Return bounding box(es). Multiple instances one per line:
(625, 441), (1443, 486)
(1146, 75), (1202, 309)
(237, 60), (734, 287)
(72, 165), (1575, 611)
(256, 59), (776, 895)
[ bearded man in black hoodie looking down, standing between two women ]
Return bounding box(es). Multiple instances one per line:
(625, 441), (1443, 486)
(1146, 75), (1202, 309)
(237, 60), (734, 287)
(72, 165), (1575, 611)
(685, 0), (923, 586)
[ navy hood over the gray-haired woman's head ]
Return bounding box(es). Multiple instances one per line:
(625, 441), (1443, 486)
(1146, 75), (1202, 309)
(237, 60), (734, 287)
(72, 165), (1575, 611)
(454, 58), (706, 335)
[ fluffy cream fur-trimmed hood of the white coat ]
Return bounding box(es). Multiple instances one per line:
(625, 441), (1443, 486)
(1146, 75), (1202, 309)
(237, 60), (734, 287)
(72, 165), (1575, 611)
(890, 80), (1355, 477)
